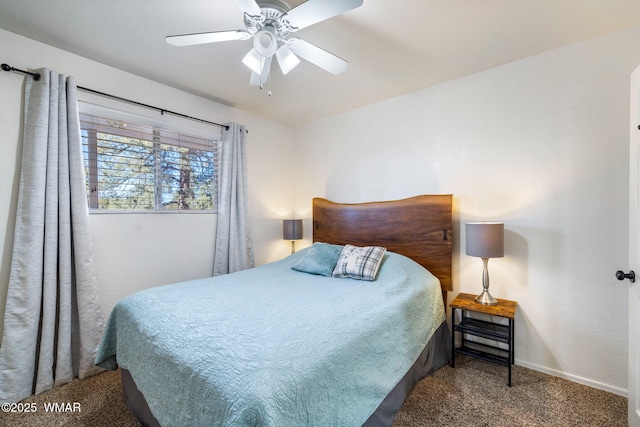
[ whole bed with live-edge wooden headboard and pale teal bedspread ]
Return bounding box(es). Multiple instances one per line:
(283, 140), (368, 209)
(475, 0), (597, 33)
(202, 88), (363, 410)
(96, 195), (452, 427)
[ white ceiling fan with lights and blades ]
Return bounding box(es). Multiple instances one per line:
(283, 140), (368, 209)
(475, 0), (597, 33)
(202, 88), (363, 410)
(166, 0), (364, 88)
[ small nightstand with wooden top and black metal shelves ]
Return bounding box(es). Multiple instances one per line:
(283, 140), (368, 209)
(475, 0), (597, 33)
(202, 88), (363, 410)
(449, 293), (518, 387)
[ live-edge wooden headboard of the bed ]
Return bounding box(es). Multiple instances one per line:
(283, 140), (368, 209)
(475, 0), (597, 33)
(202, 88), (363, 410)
(313, 194), (453, 305)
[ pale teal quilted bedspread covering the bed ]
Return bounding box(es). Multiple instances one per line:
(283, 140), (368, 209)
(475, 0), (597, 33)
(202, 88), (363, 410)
(96, 250), (445, 427)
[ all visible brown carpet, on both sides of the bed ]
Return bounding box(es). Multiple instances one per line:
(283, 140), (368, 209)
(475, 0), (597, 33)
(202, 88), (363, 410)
(0, 356), (627, 427)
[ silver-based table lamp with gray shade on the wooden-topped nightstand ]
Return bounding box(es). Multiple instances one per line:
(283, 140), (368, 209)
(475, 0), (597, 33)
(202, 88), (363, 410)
(465, 222), (504, 305)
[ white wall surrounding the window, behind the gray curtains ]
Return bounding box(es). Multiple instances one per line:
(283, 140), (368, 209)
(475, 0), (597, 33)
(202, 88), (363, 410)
(0, 30), (293, 336)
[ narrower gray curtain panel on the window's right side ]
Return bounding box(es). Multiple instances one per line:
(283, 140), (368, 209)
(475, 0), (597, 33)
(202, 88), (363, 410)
(213, 123), (254, 276)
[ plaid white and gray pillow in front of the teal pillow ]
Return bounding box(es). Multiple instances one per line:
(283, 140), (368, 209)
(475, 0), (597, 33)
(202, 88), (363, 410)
(332, 245), (387, 280)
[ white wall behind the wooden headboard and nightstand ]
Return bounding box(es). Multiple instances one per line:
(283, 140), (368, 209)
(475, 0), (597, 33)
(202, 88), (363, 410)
(295, 27), (640, 394)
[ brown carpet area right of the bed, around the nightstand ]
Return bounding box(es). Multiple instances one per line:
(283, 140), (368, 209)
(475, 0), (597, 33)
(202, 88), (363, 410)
(394, 356), (628, 427)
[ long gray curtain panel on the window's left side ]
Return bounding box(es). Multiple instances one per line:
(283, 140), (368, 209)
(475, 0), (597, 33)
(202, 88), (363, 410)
(0, 70), (105, 403)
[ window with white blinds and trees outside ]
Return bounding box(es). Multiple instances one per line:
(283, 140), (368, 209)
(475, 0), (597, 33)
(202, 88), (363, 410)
(80, 113), (219, 212)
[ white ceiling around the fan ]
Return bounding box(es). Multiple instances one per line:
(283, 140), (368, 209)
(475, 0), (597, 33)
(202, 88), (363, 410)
(0, 0), (640, 126)
